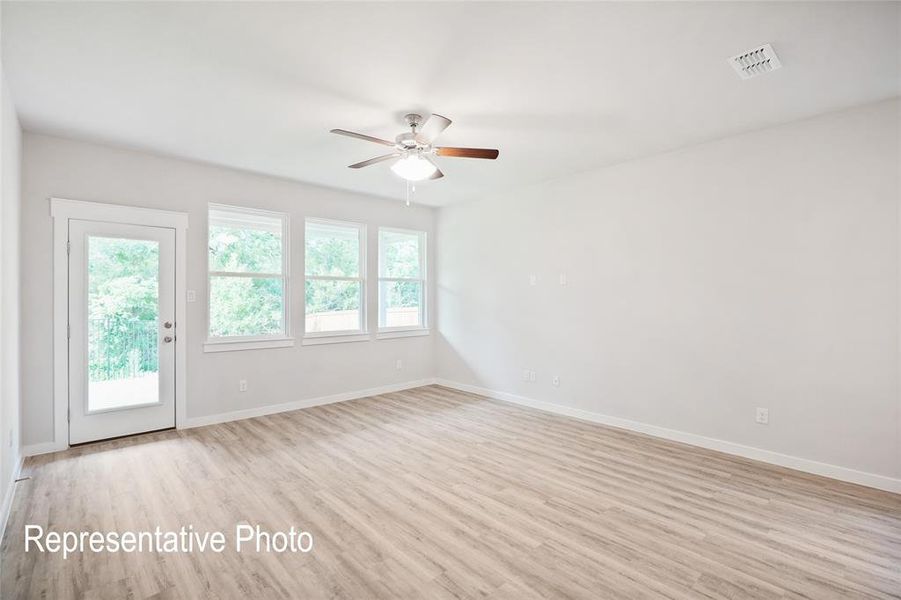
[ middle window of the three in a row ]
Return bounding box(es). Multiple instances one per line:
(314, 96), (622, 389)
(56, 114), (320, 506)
(304, 219), (366, 337)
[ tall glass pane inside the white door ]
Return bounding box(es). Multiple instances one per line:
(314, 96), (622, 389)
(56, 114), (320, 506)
(87, 236), (160, 411)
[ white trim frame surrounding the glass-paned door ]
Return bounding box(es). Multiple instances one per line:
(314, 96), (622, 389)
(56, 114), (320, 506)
(48, 198), (188, 451)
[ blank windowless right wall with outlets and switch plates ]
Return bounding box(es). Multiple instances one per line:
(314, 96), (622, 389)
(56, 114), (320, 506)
(436, 101), (901, 478)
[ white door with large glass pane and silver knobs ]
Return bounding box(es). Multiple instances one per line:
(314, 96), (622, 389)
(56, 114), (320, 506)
(69, 219), (176, 444)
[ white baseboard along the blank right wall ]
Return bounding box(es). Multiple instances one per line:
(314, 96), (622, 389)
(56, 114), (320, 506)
(435, 378), (901, 493)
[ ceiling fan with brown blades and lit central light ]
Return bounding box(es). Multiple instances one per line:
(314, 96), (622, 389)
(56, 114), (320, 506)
(331, 113), (499, 181)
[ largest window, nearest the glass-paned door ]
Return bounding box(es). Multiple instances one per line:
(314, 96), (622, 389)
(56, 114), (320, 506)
(209, 205), (289, 343)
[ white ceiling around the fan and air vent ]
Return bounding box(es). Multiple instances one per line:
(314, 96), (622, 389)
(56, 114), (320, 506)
(2, 2), (901, 205)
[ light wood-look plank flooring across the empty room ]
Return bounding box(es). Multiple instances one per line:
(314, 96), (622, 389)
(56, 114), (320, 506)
(0, 386), (901, 600)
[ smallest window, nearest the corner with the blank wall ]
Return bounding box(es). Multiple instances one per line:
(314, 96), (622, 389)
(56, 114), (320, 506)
(379, 229), (426, 330)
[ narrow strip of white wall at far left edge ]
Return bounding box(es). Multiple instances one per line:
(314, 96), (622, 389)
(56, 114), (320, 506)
(0, 70), (22, 510)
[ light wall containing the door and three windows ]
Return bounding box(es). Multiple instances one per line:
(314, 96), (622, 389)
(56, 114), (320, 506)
(22, 133), (434, 446)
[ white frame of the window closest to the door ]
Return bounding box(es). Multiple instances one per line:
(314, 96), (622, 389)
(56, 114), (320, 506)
(203, 203), (294, 352)
